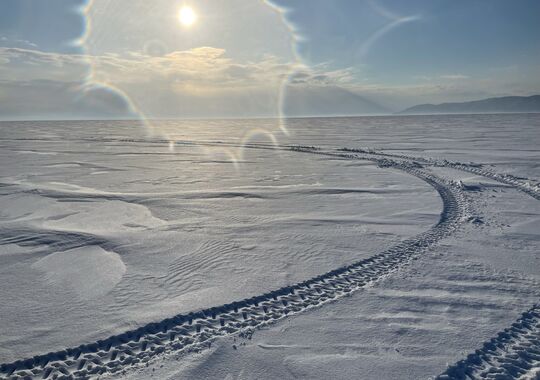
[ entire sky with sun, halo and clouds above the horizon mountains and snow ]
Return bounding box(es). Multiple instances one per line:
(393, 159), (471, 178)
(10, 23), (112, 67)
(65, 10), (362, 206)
(0, 0), (540, 119)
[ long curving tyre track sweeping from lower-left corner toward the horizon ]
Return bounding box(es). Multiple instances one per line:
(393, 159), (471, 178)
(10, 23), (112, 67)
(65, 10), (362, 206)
(0, 147), (467, 379)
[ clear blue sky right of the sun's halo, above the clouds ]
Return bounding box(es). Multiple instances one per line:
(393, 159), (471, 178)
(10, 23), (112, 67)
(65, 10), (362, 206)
(276, 0), (540, 75)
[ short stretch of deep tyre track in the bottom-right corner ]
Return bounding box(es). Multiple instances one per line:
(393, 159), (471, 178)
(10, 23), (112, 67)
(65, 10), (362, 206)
(437, 305), (540, 380)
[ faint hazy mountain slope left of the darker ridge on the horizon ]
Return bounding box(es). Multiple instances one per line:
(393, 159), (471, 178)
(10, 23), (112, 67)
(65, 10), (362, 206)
(283, 86), (389, 117)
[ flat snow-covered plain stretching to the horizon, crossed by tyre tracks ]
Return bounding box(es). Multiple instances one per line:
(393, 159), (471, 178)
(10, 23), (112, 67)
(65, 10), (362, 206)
(0, 115), (540, 379)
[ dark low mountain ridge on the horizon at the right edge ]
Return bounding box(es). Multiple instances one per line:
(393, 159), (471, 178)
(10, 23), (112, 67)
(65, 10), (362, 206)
(398, 95), (540, 115)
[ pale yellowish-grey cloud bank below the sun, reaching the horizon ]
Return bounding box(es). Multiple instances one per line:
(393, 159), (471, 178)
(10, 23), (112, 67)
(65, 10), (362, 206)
(0, 47), (362, 117)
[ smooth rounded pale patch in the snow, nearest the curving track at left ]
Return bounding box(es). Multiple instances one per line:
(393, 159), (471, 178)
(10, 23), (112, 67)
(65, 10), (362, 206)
(32, 246), (126, 299)
